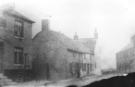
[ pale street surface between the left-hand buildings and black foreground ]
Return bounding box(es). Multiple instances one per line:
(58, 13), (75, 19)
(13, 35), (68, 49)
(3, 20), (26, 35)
(3, 74), (122, 87)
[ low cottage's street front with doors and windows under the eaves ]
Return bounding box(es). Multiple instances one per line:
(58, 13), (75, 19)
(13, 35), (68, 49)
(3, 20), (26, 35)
(68, 49), (95, 77)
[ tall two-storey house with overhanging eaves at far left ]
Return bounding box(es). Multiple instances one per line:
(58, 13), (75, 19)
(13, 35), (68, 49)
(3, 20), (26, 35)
(0, 8), (34, 80)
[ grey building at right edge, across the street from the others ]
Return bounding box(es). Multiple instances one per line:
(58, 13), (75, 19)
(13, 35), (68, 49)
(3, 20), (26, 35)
(116, 35), (135, 73)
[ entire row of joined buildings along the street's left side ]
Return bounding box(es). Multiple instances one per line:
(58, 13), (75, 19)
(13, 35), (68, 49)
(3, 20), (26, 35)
(0, 8), (97, 80)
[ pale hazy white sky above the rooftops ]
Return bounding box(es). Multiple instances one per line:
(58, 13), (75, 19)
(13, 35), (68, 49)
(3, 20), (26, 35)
(0, 0), (135, 68)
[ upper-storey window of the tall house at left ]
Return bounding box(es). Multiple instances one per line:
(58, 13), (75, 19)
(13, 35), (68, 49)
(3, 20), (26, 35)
(14, 20), (24, 38)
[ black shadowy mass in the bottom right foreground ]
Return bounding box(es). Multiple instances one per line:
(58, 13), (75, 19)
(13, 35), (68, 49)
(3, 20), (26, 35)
(67, 73), (135, 87)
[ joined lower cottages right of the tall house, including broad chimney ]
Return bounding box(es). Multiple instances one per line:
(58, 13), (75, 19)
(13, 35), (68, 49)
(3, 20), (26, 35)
(32, 20), (96, 80)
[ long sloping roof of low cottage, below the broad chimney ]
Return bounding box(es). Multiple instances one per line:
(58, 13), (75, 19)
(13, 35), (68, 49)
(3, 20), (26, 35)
(33, 30), (90, 53)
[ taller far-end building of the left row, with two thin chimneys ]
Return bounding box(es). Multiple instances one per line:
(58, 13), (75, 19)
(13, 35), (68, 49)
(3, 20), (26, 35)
(73, 29), (98, 75)
